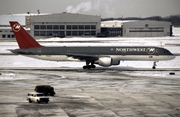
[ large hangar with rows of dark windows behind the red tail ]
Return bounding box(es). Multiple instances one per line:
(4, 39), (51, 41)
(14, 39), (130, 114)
(26, 13), (101, 38)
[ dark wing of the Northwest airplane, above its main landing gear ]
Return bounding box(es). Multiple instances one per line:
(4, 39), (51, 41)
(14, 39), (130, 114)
(66, 53), (99, 61)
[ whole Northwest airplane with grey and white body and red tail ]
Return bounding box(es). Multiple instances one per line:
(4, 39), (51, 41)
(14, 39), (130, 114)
(9, 21), (175, 69)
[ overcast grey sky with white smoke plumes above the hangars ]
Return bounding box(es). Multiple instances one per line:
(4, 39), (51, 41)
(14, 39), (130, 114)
(0, 0), (180, 18)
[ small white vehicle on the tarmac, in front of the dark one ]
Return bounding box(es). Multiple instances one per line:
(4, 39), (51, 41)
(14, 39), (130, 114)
(27, 92), (49, 103)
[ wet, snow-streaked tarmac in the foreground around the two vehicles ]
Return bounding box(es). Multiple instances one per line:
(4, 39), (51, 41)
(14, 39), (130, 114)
(0, 68), (180, 117)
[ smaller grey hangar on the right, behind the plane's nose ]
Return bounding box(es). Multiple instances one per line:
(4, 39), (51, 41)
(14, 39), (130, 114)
(122, 20), (172, 37)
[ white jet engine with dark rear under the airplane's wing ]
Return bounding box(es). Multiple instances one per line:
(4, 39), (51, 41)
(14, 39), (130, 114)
(95, 57), (120, 67)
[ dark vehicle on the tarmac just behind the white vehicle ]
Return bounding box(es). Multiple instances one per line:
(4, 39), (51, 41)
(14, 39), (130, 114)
(34, 85), (56, 96)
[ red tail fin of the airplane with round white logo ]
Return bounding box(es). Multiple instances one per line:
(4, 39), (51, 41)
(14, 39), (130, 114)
(9, 21), (41, 48)
